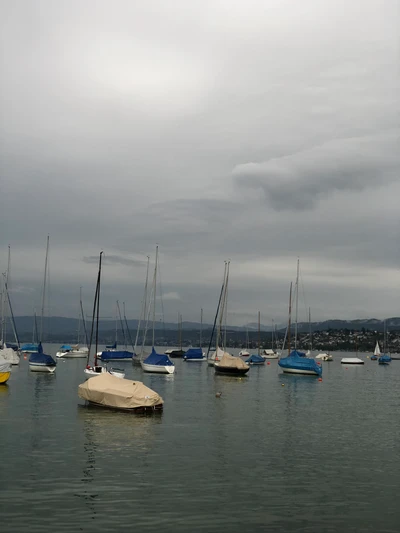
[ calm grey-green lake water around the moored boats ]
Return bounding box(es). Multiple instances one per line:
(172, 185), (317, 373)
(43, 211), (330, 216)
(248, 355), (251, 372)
(0, 346), (400, 533)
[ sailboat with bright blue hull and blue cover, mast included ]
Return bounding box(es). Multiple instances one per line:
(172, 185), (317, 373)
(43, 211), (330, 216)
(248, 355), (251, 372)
(278, 259), (322, 376)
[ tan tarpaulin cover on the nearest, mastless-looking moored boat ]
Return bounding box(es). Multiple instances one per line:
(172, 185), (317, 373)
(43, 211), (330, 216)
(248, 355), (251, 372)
(78, 372), (164, 409)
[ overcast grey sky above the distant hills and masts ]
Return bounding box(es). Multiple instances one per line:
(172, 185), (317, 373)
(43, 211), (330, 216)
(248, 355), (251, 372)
(0, 0), (400, 325)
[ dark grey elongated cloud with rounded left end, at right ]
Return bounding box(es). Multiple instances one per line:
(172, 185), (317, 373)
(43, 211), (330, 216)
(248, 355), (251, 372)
(233, 131), (400, 211)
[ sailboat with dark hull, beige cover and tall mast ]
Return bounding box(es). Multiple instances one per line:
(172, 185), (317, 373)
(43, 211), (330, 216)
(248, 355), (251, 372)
(214, 261), (250, 376)
